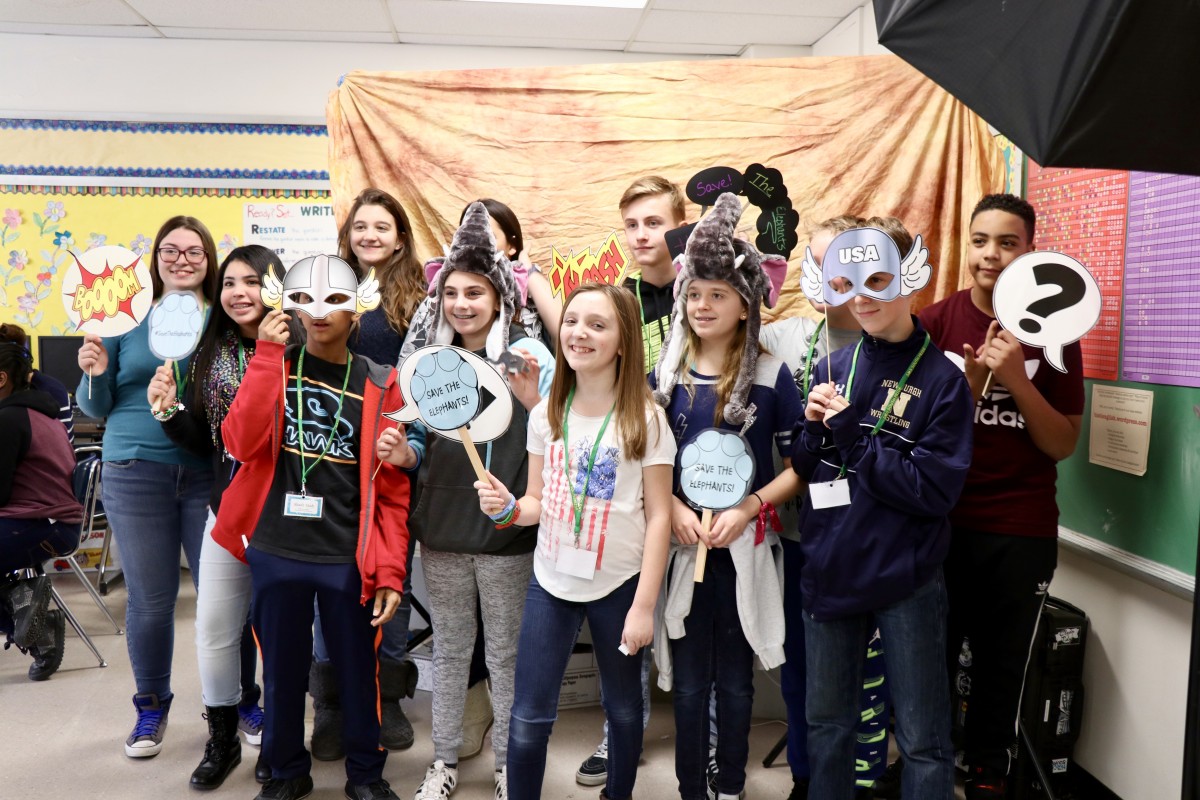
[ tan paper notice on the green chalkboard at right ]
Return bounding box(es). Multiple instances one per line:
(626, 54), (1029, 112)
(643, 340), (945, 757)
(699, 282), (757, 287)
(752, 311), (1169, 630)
(1087, 384), (1154, 475)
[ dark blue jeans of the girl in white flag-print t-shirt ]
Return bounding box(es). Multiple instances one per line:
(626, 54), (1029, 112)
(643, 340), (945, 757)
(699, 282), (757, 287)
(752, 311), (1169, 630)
(509, 576), (642, 800)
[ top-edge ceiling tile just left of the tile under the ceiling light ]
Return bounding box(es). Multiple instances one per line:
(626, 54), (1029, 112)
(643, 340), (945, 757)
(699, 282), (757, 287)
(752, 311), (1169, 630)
(127, 0), (391, 31)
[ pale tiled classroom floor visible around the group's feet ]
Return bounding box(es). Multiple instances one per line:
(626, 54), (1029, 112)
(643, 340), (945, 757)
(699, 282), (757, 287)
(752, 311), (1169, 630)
(0, 573), (792, 800)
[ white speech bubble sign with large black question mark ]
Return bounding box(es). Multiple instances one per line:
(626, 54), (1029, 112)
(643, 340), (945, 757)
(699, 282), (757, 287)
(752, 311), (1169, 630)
(991, 251), (1103, 372)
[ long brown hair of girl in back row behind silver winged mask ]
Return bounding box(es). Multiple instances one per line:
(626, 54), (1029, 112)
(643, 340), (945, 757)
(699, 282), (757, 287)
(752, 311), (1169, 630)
(337, 188), (425, 336)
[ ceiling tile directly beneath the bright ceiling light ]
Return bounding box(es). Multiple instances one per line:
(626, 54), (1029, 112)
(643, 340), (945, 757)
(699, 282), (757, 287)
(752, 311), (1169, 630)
(388, 0), (642, 41)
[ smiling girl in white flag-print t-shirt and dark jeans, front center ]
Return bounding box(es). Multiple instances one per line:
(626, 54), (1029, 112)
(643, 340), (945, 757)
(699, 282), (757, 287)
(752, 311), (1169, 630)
(475, 283), (676, 800)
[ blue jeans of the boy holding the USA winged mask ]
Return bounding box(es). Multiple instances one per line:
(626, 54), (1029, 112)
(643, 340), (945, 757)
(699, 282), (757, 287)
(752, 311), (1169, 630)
(804, 571), (954, 800)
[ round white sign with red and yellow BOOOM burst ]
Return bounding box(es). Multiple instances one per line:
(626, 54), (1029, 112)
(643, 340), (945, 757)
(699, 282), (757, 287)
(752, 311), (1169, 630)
(62, 245), (154, 336)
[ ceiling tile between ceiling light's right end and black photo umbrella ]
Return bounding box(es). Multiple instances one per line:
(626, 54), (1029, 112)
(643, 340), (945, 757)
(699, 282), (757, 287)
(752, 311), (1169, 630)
(637, 11), (839, 44)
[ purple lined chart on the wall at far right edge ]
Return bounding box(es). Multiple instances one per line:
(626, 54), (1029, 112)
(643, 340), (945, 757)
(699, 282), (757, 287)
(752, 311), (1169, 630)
(1121, 173), (1200, 386)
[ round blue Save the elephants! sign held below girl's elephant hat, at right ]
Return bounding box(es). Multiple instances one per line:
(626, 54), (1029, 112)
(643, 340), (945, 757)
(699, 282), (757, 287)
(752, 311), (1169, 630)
(679, 428), (755, 511)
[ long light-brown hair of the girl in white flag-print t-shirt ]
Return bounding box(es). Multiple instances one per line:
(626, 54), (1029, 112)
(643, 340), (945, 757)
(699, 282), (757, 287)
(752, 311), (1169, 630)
(546, 283), (662, 461)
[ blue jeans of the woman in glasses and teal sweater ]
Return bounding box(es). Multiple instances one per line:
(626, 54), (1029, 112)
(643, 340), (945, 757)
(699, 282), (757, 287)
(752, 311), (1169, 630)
(102, 459), (212, 699)
